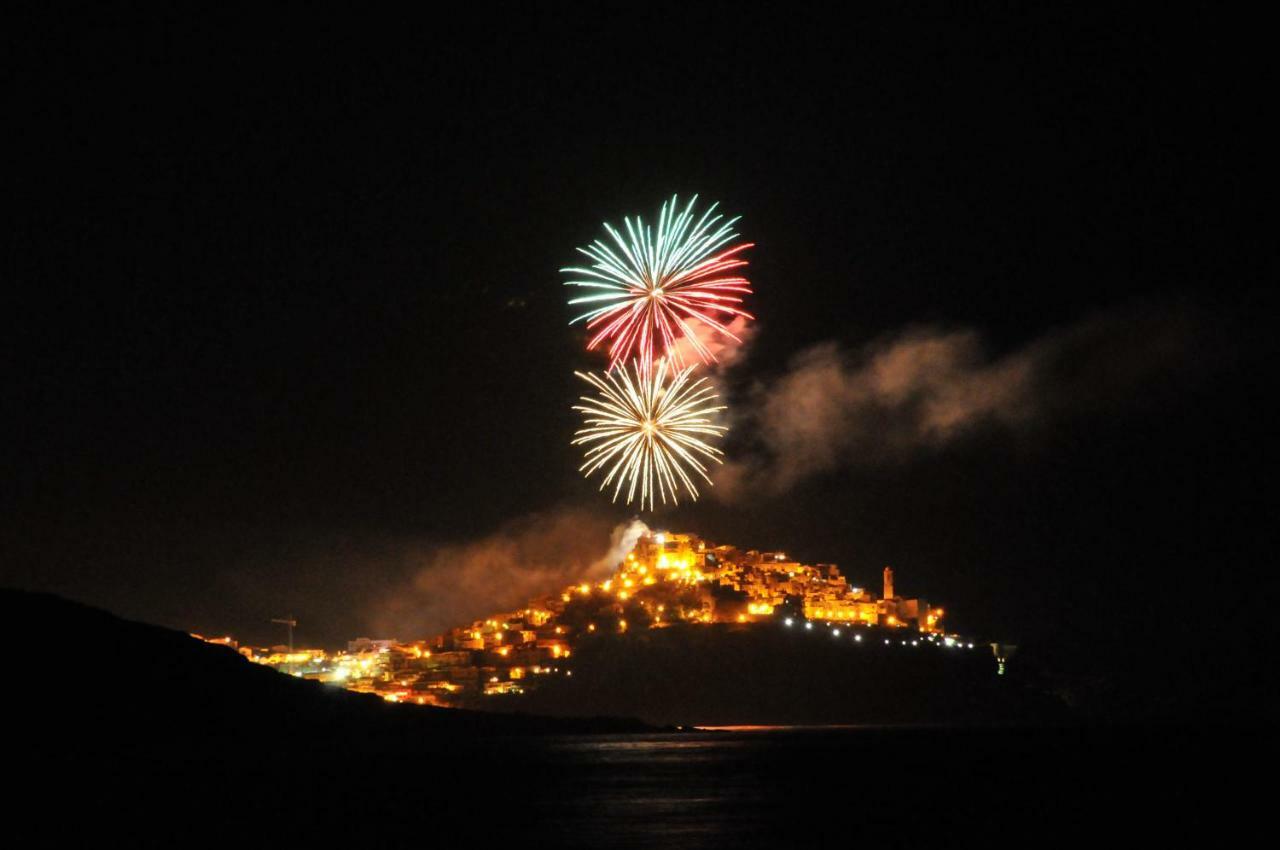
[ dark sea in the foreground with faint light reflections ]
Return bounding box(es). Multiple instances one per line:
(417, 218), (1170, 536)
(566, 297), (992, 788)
(55, 728), (1254, 847)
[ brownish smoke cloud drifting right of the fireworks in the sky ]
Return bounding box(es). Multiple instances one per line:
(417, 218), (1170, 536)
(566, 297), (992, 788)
(712, 303), (1193, 501)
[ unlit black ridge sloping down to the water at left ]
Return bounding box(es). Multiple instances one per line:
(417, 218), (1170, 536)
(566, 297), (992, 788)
(0, 589), (653, 760)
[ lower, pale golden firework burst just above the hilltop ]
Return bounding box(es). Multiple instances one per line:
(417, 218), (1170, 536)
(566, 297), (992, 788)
(572, 360), (728, 511)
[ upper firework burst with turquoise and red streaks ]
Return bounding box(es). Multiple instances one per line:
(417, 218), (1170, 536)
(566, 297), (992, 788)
(561, 195), (754, 371)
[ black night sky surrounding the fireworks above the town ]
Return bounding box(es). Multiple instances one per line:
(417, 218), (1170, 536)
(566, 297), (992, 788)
(0, 8), (1274, 704)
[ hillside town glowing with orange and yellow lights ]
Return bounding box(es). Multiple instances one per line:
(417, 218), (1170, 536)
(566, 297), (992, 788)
(197, 531), (977, 705)
